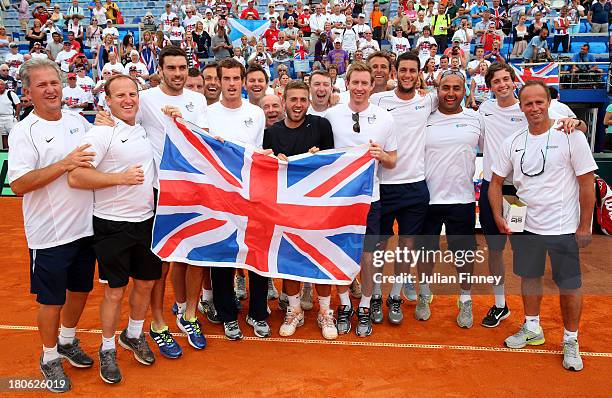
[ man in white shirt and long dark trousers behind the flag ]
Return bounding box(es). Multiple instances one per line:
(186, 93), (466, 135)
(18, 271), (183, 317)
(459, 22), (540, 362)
(208, 58), (270, 340)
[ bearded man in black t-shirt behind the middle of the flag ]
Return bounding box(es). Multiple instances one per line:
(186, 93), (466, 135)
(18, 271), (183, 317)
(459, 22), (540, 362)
(263, 81), (338, 340)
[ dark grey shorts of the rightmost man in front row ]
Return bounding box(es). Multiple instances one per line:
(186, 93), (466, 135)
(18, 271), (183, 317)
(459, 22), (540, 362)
(510, 231), (582, 289)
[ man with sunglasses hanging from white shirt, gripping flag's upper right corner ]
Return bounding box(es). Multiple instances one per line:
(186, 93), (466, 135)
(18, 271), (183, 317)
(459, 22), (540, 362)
(325, 61), (397, 337)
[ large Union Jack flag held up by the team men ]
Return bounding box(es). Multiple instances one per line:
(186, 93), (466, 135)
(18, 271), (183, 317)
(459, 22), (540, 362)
(152, 119), (376, 284)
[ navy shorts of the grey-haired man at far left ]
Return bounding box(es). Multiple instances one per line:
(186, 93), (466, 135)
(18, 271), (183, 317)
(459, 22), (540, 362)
(30, 236), (96, 305)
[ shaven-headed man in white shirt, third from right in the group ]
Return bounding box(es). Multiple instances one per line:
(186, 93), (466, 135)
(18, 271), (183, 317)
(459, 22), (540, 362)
(415, 70), (483, 328)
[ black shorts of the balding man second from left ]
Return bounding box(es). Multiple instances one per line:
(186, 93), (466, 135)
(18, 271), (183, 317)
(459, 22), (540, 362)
(93, 217), (162, 288)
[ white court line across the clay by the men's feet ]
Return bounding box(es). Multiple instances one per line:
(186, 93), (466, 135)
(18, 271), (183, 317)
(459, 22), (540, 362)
(0, 325), (612, 358)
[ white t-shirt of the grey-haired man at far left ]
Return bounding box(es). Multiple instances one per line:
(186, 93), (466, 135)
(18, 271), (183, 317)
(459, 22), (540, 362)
(8, 110), (93, 249)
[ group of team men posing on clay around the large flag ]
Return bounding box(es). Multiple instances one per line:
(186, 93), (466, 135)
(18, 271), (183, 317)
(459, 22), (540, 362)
(9, 41), (596, 392)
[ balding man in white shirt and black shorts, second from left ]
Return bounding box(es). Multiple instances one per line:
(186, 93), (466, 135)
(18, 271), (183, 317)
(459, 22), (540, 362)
(68, 75), (161, 384)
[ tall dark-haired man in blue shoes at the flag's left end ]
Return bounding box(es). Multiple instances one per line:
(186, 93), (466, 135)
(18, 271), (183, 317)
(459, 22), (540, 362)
(96, 46), (208, 359)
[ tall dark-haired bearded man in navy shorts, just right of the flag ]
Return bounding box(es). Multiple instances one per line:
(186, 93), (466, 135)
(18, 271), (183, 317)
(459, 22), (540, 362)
(370, 53), (437, 325)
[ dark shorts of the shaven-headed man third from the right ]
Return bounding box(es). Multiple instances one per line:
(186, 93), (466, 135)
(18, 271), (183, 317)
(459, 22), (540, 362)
(417, 203), (476, 251)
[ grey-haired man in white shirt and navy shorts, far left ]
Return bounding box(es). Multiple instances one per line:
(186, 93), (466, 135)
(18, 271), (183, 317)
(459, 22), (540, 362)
(8, 59), (95, 392)
